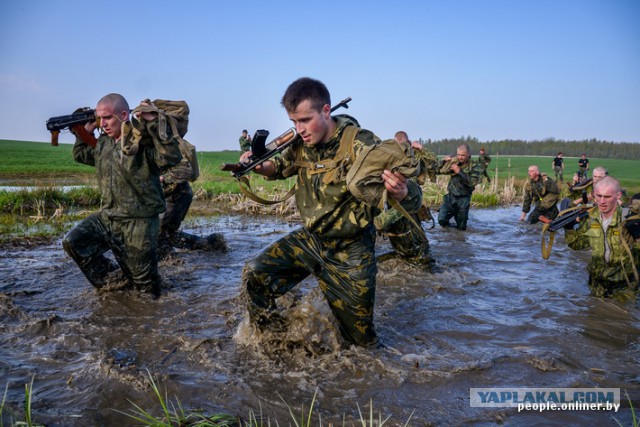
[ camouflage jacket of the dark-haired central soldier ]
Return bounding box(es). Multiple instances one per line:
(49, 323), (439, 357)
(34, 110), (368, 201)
(271, 115), (422, 239)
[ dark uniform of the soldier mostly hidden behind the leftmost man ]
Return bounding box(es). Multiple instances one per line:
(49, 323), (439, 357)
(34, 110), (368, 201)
(158, 157), (226, 259)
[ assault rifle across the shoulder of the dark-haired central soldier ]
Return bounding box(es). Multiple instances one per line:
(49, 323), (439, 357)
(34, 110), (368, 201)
(220, 97), (351, 178)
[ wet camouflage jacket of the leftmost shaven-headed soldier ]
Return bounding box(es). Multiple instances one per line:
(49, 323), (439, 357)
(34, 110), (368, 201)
(73, 120), (182, 218)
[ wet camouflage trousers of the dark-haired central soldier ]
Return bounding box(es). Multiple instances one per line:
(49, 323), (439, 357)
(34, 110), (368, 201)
(242, 227), (377, 346)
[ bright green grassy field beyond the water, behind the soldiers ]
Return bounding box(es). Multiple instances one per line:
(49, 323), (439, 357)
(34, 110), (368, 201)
(0, 140), (640, 196)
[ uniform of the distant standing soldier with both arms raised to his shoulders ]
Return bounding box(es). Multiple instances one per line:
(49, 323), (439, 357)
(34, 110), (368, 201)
(438, 157), (482, 230)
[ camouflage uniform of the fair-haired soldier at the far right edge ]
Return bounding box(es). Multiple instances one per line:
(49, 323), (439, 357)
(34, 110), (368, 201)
(565, 207), (640, 297)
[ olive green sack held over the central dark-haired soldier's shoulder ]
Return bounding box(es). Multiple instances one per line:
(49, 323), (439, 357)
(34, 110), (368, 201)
(347, 139), (420, 209)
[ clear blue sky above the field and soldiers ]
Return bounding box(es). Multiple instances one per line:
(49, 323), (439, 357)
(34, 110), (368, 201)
(0, 0), (640, 152)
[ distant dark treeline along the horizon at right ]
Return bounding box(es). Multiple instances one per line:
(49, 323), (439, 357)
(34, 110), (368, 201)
(419, 136), (640, 160)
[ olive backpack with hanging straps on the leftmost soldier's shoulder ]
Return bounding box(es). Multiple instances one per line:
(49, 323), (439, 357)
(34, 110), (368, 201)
(132, 99), (200, 182)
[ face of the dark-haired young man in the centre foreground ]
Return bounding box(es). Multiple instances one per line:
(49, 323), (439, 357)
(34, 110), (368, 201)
(287, 99), (333, 147)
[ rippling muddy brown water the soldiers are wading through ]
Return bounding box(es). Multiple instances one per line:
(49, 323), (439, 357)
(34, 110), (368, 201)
(0, 207), (640, 426)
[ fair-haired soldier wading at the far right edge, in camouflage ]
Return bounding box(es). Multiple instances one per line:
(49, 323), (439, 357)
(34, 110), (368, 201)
(565, 177), (640, 297)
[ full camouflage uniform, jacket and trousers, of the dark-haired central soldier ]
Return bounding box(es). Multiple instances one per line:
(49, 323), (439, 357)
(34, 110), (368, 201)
(242, 116), (421, 345)
